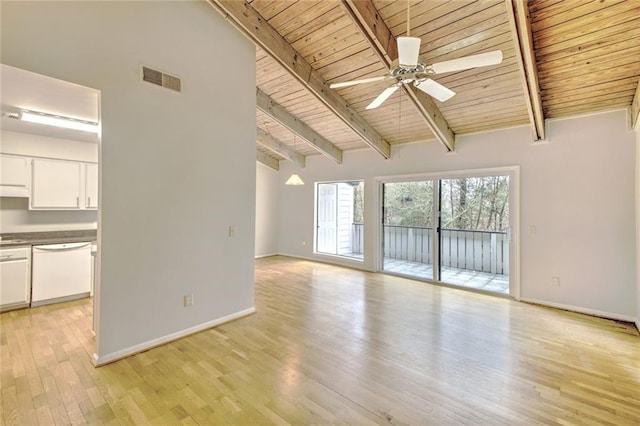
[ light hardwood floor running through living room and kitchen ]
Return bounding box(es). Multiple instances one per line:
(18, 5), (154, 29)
(0, 257), (640, 425)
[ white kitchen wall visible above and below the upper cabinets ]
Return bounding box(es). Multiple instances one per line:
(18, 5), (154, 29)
(0, 130), (98, 233)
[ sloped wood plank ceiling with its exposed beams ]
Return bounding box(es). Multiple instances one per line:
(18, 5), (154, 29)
(209, 0), (640, 167)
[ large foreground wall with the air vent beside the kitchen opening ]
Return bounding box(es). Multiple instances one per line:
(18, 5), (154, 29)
(2, 2), (256, 363)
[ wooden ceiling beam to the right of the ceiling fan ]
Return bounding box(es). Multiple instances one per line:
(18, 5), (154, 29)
(505, 0), (546, 140)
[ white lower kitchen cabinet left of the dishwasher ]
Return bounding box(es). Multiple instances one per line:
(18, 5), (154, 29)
(0, 249), (31, 308)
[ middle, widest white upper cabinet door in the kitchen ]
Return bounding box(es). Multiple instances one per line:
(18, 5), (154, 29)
(31, 159), (81, 209)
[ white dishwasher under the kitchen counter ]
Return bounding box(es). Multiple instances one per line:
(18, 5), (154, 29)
(31, 242), (92, 306)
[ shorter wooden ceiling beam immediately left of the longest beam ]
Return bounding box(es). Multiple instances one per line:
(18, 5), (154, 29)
(256, 89), (342, 164)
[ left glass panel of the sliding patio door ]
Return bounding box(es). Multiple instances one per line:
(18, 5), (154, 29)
(382, 181), (434, 279)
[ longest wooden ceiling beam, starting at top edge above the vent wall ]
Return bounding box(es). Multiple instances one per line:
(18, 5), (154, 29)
(208, 0), (391, 158)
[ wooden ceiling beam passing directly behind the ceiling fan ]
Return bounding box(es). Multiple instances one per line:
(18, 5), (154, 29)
(342, 0), (455, 151)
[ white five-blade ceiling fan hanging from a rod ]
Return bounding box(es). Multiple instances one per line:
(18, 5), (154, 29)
(329, 2), (502, 109)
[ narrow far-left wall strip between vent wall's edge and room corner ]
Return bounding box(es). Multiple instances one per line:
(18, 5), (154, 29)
(255, 162), (280, 257)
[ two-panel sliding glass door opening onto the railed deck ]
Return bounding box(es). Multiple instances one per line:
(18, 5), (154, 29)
(382, 173), (511, 294)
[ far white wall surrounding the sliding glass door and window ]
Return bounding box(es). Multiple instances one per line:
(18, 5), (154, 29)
(278, 110), (636, 319)
